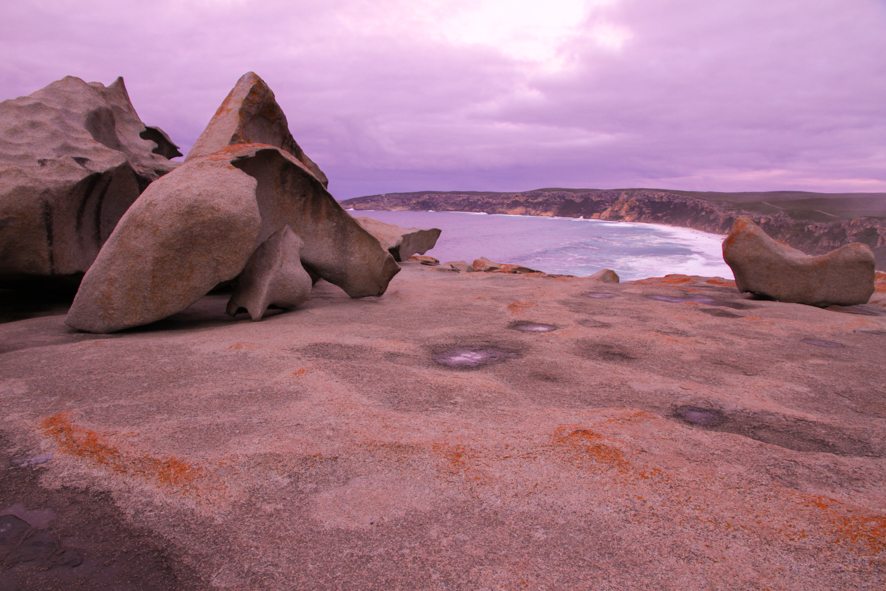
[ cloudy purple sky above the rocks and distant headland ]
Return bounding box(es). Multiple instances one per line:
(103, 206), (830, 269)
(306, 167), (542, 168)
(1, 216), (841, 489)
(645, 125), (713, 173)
(0, 0), (886, 198)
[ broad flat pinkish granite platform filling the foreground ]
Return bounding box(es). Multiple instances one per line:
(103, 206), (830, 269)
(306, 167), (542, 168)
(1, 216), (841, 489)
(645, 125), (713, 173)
(0, 264), (886, 591)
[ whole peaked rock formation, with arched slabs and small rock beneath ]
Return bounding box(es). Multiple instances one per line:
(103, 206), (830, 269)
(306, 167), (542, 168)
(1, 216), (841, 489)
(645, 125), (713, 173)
(66, 74), (400, 332)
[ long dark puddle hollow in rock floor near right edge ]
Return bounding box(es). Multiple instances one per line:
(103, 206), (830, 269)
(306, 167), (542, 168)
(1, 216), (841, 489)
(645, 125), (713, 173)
(670, 405), (882, 457)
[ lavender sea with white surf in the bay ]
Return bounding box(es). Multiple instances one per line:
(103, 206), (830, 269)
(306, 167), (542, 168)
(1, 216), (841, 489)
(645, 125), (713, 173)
(351, 210), (732, 280)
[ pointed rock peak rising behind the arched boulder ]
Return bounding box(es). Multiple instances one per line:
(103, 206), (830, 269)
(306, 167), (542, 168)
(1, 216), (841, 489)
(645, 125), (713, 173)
(186, 72), (328, 187)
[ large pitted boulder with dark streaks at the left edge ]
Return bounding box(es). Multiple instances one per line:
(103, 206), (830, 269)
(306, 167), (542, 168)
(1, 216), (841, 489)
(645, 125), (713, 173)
(0, 76), (180, 280)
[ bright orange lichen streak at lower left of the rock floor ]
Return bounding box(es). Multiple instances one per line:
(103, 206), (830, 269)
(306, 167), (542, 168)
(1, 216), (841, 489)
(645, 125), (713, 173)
(40, 412), (203, 488)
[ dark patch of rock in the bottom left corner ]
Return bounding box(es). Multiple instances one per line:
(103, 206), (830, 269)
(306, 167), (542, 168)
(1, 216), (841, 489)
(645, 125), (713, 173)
(0, 437), (209, 591)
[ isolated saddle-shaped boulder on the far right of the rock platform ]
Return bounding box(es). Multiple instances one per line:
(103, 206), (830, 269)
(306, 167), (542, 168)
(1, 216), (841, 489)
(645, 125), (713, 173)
(723, 217), (874, 306)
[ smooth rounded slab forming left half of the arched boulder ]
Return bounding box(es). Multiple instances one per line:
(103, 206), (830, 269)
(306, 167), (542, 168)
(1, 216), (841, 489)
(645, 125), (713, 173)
(65, 160), (262, 332)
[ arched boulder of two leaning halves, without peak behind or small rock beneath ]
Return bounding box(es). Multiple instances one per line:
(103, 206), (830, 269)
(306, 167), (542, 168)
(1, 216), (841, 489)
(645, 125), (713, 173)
(66, 144), (400, 332)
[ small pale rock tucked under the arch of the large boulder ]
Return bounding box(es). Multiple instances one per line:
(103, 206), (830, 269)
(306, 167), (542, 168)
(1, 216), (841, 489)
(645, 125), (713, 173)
(228, 226), (313, 320)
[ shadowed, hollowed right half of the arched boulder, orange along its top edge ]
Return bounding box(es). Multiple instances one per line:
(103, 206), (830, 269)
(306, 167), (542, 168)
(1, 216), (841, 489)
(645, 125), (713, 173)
(227, 144), (400, 298)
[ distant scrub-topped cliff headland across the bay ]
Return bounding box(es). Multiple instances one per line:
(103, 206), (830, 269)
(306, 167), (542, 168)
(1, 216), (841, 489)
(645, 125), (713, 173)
(343, 189), (886, 269)
